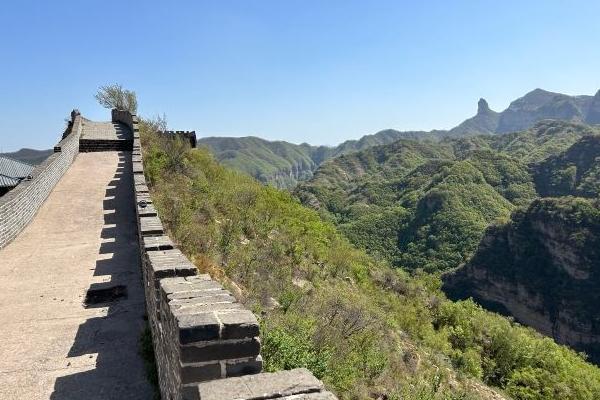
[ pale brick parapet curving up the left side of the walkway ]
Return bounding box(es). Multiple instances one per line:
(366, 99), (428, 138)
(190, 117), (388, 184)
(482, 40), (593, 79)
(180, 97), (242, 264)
(0, 112), (82, 248)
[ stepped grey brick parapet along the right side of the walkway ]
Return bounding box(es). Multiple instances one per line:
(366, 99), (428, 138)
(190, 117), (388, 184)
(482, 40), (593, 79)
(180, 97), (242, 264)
(128, 111), (335, 400)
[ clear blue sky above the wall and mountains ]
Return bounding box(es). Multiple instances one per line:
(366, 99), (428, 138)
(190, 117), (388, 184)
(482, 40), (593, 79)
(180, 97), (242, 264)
(0, 0), (600, 151)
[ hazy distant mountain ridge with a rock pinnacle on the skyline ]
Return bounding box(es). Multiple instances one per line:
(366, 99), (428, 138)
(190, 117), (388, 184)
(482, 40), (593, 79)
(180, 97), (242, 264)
(198, 89), (600, 188)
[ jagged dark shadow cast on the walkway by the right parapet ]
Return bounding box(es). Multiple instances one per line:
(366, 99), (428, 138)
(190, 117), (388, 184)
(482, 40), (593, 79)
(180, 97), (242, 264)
(51, 152), (152, 400)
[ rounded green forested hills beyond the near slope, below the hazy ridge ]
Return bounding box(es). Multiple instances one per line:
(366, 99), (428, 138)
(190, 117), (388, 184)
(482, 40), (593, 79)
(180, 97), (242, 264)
(295, 121), (600, 272)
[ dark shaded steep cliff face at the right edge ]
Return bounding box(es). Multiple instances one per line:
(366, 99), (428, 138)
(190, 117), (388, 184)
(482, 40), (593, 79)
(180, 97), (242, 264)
(444, 197), (600, 363)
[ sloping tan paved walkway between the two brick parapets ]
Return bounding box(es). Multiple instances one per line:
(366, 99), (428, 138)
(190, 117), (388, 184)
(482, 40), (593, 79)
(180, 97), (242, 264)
(0, 152), (152, 400)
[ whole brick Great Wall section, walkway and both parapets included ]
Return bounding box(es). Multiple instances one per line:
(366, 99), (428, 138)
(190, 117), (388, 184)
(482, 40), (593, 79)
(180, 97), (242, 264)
(0, 110), (335, 400)
